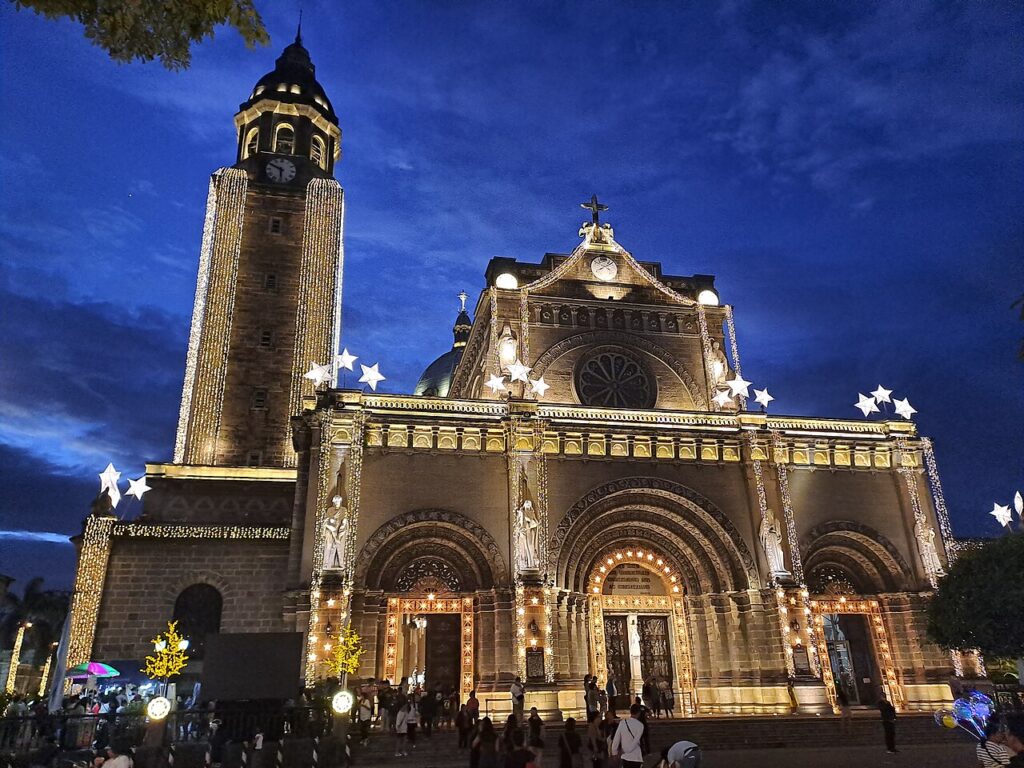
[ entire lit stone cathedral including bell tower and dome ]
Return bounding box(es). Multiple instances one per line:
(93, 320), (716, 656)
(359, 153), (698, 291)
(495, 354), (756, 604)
(68, 39), (966, 716)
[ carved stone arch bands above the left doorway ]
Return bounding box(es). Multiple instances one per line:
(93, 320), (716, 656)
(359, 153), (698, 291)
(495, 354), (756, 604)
(355, 509), (508, 592)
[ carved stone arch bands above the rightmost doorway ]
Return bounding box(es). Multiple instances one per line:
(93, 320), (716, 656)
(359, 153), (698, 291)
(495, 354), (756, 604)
(800, 520), (913, 592)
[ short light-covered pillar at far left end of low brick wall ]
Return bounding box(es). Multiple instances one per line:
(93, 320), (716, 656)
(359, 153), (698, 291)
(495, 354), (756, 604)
(68, 515), (115, 667)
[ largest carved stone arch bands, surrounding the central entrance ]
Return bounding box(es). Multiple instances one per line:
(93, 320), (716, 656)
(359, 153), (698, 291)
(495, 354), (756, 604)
(549, 477), (760, 594)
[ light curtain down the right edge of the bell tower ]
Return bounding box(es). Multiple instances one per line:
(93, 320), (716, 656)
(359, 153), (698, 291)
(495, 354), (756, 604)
(283, 178), (345, 466)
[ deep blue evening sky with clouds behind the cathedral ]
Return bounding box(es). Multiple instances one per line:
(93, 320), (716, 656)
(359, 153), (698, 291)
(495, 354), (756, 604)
(0, 0), (1024, 587)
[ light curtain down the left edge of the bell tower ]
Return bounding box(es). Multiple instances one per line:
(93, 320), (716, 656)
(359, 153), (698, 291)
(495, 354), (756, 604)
(174, 168), (249, 464)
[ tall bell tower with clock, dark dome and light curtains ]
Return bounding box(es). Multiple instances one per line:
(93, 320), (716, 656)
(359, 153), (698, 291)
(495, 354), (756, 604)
(174, 33), (344, 467)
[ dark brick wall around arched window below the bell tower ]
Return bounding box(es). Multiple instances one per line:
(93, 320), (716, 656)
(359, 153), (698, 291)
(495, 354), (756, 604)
(92, 539), (291, 659)
